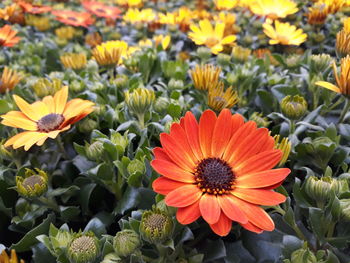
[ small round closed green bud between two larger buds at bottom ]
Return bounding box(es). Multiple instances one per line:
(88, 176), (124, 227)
(113, 229), (141, 257)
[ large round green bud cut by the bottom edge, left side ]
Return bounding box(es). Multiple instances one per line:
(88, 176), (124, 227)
(68, 232), (100, 263)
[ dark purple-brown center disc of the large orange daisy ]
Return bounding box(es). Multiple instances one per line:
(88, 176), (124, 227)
(195, 158), (235, 195)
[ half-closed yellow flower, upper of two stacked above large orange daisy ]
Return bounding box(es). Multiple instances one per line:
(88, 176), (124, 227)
(189, 64), (221, 91)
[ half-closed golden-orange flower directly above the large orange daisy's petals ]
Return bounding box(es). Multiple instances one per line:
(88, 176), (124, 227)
(208, 81), (239, 112)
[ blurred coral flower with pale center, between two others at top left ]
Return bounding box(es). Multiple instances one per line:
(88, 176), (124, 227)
(52, 10), (94, 27)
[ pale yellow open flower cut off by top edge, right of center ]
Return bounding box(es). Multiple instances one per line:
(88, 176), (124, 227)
(249, 0), (298, 19)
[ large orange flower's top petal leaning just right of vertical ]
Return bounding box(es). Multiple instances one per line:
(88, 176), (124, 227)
(211, 109), (232, 158)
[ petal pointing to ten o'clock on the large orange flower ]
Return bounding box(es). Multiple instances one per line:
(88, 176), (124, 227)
(160, 133), (195, 172)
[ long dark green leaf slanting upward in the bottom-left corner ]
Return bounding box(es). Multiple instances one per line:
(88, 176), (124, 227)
(11, 214), (55, 252)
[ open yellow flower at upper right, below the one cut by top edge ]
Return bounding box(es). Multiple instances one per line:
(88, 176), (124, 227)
(263, 20), (307, 46)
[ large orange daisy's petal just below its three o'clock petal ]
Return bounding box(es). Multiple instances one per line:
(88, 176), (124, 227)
(232, 188), (286, 205)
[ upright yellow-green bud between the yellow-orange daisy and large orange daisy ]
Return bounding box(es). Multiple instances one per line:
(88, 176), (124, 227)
(125, 88), (155, 115)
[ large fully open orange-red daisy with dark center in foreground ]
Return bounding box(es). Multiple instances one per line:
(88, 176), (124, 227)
(151, 109), (290, 236)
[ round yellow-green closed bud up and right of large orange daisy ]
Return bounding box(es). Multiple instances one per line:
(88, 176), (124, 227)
(280, 95), (307, 120)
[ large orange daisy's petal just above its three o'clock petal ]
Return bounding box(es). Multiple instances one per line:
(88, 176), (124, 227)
(234, 150), (282, 176)
